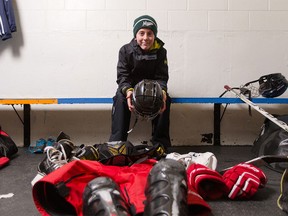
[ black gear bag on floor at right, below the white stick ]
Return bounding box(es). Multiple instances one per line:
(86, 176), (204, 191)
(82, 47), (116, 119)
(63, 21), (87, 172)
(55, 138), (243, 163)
(252, 115), (288, 172)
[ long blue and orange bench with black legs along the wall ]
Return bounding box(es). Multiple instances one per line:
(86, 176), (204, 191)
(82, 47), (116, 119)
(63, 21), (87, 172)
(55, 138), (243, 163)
(0, 97), (288, 147)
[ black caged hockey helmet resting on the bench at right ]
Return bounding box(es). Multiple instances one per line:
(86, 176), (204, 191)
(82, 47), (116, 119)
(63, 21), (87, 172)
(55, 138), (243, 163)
(259, 73), (288, 98)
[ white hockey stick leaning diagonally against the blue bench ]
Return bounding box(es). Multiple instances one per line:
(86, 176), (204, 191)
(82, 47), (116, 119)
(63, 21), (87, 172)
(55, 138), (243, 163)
(224, 85), (288, 132)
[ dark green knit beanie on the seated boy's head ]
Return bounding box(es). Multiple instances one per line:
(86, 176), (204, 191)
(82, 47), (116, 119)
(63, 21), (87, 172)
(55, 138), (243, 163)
(133, 15), (157, 37)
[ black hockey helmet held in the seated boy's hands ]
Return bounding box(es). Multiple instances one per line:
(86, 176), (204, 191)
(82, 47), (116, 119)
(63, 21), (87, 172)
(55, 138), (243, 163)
(132, 79), (163, 120)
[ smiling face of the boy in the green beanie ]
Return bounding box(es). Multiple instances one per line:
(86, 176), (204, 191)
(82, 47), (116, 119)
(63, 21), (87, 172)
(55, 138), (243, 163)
(136, 28), (155, 51)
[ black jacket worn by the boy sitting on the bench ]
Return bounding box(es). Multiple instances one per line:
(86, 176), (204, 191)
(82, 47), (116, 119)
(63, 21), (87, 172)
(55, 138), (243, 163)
(117, 38), (169, 95)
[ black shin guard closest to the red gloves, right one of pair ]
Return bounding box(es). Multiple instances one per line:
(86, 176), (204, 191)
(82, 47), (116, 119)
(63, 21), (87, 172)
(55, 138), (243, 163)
(144, 159), (188, 216)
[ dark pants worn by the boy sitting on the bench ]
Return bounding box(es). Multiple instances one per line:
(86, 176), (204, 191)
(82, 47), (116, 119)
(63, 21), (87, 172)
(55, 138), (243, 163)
(109, 91), (171, 148)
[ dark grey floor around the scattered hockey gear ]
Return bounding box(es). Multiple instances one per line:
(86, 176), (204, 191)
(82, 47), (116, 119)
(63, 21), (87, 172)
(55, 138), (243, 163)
(0, 146), (286, 216)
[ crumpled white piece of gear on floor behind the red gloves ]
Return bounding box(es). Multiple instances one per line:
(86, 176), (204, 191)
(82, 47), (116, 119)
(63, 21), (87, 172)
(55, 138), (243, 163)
(166, 152), (217, 170)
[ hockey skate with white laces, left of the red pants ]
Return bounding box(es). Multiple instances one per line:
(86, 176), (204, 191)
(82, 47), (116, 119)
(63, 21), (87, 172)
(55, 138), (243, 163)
(31, 139), (75, 186)
